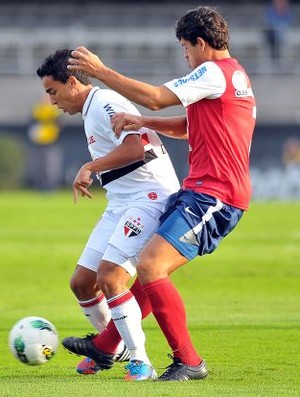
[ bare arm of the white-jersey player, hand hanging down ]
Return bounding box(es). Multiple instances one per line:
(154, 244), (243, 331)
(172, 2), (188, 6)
(73, 134), (145, 203)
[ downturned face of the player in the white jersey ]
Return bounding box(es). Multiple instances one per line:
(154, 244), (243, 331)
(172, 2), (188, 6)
(42, 76), (82, 115)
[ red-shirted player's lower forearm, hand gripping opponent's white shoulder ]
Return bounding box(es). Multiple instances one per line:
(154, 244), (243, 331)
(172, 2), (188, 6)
(111, 113), (188, 139)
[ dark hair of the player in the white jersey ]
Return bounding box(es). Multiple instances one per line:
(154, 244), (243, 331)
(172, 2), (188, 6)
(36, 48), (91, 85)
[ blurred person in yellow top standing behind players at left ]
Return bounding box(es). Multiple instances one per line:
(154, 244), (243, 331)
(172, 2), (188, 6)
(28, 96), (62, 191)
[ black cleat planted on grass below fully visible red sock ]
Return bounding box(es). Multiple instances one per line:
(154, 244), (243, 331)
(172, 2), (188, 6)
(157, 357), (208, 381)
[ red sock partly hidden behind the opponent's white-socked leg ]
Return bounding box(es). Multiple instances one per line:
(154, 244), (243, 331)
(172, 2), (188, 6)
(93, 278), (152, 353)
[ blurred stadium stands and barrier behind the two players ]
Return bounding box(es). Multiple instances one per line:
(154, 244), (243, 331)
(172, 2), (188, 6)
(0, 0), (300, 199)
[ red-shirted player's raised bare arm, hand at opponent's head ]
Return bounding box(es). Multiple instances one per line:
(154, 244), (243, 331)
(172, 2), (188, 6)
(68, 47), (181, 110)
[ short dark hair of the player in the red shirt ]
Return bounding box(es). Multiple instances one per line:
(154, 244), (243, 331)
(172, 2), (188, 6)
(176, 7), (229, 50)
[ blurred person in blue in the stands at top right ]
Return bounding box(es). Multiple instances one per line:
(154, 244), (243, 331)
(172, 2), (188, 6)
(265, 0), (293, 61)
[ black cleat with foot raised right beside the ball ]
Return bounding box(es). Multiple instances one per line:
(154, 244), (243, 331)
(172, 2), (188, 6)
(62, 334), (115, 370)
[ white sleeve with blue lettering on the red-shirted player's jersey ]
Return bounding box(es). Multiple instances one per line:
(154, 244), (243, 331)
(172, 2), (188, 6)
(164, 62), (226, 107)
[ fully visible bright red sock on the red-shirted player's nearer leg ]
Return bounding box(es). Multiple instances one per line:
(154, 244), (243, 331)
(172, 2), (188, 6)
(143, 278), (202, 365)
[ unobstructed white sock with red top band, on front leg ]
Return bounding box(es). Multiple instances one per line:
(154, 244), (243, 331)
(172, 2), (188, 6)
(107, 291), (151, 365)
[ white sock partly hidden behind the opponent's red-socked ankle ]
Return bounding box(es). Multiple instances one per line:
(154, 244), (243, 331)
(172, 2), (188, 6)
(78, 293), (125, 354)
